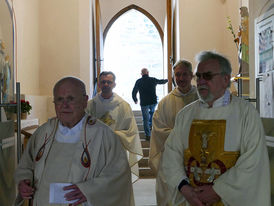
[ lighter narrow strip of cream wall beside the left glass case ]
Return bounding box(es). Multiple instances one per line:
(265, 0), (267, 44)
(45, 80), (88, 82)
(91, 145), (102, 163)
(14, 0), (40, 94)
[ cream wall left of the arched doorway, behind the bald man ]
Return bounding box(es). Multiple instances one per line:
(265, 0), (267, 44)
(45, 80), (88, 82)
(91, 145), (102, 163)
(11, 0), (91, 123)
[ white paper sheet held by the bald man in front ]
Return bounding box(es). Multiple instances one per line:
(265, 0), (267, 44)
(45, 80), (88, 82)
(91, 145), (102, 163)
(49, 183), (76, 204)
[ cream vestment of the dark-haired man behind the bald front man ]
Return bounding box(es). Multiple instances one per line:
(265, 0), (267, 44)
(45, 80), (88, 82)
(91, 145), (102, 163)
(86, 93), (143, 182)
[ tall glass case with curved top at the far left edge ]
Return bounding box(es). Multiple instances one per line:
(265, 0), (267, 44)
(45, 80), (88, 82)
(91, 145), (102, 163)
(0, 0), (21, 205)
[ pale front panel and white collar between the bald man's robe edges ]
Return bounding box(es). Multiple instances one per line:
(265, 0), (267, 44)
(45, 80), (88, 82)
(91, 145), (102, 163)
(34, 118), (91, 206)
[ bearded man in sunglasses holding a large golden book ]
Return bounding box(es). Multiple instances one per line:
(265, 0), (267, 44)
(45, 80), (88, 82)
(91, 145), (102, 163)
(160, 51), (271, 206)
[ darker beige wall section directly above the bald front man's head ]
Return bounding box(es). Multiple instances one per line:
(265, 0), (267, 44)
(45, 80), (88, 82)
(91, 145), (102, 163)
(39, 0), (80, 95)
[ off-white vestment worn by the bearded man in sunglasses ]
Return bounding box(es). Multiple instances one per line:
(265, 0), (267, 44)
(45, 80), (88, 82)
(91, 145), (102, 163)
(160, 96), (270, 206)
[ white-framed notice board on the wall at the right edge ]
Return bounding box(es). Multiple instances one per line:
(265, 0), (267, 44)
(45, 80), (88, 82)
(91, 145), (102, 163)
(255, 8), (274, 119)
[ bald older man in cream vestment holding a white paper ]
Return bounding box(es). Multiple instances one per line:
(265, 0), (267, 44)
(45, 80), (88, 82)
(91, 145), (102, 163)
(15, 77), (132, 206)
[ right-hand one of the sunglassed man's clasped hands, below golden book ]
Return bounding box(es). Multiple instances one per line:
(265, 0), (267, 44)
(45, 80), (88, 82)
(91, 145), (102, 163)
(195, 185), (221, 206)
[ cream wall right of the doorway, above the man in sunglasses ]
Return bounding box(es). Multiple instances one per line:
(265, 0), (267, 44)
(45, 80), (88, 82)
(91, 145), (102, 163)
(179, 0), (240, 77)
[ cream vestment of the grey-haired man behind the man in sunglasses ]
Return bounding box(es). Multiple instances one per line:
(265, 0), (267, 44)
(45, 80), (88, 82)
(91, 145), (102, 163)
(149, 87), (198, 206)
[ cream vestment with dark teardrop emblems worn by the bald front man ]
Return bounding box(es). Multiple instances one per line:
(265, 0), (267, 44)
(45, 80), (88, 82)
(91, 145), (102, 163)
(15, 115), (132, 206)
